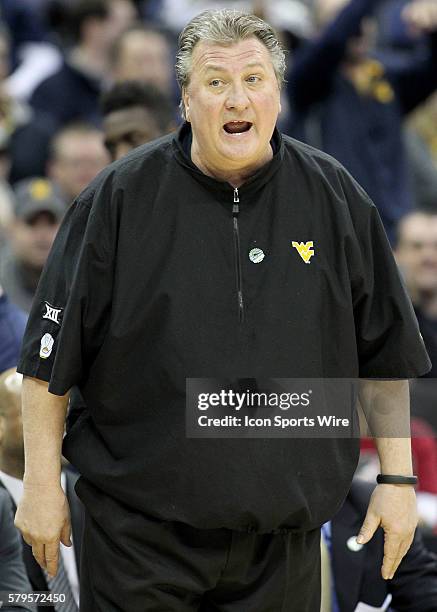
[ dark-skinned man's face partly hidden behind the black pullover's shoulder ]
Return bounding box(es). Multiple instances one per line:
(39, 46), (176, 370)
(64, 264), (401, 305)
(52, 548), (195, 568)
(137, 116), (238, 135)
(103, 106), (163, 160)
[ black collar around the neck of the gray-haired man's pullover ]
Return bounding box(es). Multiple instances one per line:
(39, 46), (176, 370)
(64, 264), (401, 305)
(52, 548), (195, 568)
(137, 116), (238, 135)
(173, 122), (284, 201)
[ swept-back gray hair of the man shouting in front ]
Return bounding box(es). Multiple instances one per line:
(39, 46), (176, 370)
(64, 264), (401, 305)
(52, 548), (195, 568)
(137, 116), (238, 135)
(176, 9), (285, 118)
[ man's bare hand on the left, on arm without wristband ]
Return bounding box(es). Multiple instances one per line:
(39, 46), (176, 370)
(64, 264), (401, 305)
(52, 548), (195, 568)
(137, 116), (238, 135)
(15, 483), (71, 577)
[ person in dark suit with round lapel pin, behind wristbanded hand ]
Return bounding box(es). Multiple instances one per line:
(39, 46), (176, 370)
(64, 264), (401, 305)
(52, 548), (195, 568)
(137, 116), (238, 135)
(322, 479), (437, 612)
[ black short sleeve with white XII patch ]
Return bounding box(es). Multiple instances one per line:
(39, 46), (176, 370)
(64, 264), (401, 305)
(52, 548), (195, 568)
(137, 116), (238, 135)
(17, 170), (116, 395)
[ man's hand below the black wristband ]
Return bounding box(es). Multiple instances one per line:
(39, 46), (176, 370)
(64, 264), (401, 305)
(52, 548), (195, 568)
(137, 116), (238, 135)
(357, 484), (418, 580)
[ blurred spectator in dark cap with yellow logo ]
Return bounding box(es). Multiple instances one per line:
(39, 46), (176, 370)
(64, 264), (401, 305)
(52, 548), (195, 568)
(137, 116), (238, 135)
(0, 179), (65, 312)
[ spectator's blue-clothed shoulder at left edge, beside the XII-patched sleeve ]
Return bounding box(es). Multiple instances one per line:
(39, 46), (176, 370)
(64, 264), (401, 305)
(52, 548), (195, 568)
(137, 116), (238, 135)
(0, 285), (27, 374)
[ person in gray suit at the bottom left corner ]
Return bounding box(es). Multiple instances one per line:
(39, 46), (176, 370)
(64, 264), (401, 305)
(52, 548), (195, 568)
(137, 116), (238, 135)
(0, 489), (35, 612)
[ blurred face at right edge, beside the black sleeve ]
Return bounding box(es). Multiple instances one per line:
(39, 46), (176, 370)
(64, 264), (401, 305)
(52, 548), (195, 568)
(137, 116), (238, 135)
(395, 213), (437, 292)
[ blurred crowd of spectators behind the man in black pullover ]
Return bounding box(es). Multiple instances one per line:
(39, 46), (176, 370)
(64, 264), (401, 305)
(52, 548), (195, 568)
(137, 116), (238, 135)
(0, 0), (437, 610)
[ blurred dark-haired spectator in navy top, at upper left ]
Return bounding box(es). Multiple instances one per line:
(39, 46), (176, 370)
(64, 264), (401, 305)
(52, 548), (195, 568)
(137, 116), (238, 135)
(31, 0), (136, 126)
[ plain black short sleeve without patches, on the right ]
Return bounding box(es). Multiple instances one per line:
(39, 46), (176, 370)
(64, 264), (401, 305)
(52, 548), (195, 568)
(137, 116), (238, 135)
(344, 170), (431, 378)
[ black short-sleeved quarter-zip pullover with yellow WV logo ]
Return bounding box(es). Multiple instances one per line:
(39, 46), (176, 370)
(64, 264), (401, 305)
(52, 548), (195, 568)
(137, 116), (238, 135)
(19, 124), (429, 532)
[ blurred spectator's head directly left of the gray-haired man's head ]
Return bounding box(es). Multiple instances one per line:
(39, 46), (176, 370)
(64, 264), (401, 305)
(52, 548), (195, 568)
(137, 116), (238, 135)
(111, 25), (174, 97)
